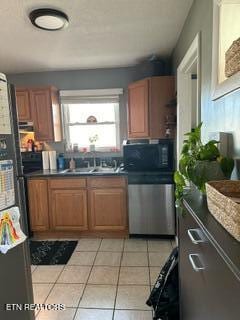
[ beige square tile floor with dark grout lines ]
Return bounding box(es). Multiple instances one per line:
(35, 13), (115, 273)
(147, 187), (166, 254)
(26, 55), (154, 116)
(32, 239), (174, 320)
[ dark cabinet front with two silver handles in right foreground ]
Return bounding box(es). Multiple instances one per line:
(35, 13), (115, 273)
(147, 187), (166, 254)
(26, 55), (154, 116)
(179, 212), (240, 320)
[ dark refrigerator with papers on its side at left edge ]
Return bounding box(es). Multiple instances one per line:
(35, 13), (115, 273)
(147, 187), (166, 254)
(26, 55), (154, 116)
(0, 73), (35, 320)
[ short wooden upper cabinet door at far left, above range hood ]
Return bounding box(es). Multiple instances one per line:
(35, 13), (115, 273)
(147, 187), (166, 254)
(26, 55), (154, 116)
(16, 89), (32, 121)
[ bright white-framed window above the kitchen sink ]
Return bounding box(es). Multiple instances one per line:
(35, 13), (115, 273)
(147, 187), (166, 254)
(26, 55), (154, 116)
(61, 89), (123, 151)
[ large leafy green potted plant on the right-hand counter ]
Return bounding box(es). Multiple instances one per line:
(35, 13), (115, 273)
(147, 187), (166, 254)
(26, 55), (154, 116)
(174, 123), (234, 206)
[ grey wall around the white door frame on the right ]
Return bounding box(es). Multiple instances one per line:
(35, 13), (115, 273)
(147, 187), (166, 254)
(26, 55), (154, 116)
(172, 0), (240, 176)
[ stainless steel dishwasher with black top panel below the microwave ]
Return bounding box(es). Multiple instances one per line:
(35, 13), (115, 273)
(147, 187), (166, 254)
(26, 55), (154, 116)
(128, 172), (175, 235)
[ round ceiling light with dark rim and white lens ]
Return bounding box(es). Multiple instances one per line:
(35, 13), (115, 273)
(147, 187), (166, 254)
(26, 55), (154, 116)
(29, 8), (68, 31)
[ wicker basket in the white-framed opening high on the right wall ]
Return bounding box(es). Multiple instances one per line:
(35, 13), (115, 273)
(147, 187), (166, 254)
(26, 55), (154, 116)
(225, 38), (240, 78)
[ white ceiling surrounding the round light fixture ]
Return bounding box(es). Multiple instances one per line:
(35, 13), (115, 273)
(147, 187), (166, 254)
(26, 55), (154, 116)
(0, 0), (193, 73)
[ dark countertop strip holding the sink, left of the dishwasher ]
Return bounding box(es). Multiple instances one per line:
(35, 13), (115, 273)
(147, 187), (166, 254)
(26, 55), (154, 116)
(24, 170), (127, 178)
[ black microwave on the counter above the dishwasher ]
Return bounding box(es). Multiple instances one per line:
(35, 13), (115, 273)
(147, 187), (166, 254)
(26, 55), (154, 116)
(123, 139), (174, 171)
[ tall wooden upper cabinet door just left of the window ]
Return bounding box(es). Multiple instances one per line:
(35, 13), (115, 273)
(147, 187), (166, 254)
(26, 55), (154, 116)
(30, 89), (54, 141)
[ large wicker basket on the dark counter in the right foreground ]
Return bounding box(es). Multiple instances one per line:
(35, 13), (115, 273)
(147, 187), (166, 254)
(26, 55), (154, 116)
(206, 180), (240, 241)
